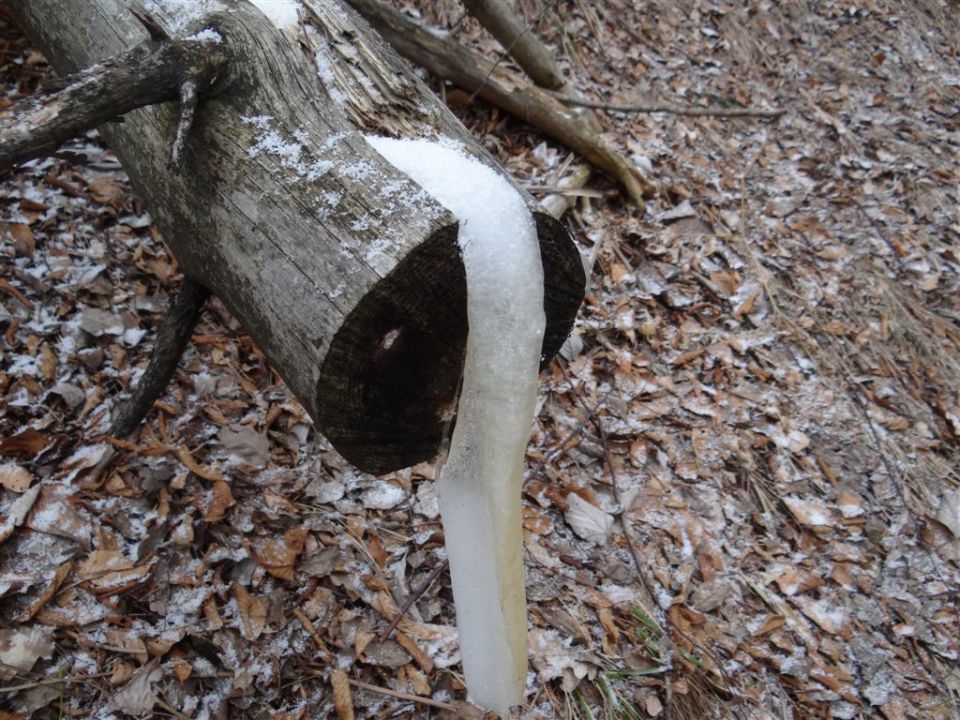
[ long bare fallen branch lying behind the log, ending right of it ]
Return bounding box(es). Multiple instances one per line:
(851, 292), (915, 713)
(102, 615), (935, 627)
(347, 0), (656, 208)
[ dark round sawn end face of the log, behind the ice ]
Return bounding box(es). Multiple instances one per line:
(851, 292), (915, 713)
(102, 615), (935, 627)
(314, 213), (586, 474)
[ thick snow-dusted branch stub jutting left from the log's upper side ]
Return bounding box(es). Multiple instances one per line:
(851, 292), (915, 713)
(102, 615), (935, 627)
(0, 29), (227, 170)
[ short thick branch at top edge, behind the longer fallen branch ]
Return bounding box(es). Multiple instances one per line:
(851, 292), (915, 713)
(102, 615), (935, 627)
(463, 0), (564, 90)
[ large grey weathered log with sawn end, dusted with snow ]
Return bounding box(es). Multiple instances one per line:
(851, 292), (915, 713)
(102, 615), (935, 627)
(8, 0), (584, 472)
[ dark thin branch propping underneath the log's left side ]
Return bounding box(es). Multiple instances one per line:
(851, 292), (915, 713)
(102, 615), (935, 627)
(110, 276), (208, 438)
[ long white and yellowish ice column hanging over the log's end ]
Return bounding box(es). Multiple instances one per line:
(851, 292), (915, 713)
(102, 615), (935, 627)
(367, 137), (545, 717)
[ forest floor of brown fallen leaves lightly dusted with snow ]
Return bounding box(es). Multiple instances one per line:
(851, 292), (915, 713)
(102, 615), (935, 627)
(0, 0), (960, 720)
